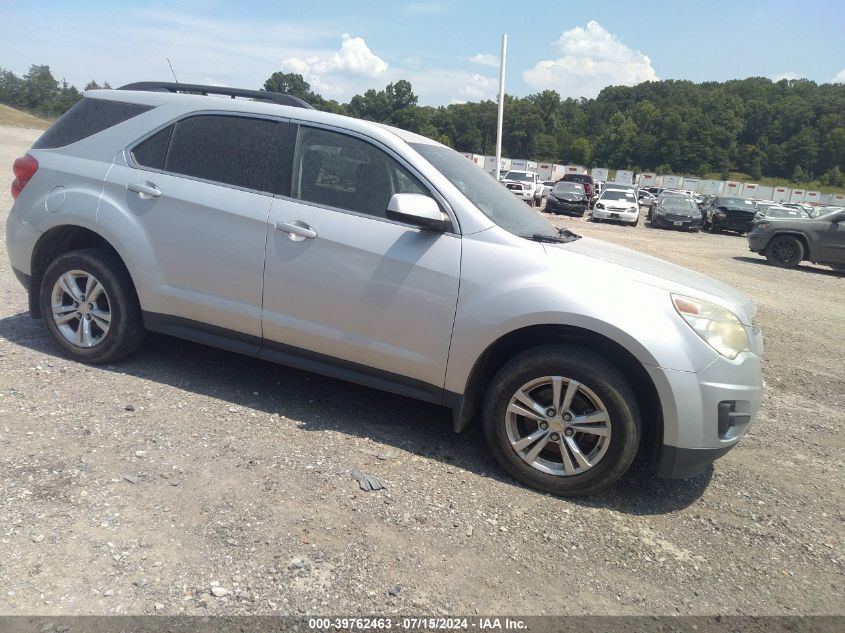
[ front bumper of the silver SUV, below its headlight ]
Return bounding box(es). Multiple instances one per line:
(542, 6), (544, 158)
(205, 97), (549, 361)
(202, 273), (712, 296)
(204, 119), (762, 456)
(646, 346), (763, 478)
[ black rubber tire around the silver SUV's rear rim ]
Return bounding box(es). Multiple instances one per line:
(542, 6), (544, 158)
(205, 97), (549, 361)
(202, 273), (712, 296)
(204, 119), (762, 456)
(40, 248), (146, 364)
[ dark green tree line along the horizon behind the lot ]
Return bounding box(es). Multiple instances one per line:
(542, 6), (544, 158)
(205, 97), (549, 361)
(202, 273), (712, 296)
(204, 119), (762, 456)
(0, 65), (845, 187)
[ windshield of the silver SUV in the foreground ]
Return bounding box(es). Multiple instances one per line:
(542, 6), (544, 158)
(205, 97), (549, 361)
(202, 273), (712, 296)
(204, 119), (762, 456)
(411, 143), (559, 237)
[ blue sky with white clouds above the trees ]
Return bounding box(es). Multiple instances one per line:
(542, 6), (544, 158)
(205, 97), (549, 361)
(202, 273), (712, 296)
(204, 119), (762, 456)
(0, 0), (845, 105)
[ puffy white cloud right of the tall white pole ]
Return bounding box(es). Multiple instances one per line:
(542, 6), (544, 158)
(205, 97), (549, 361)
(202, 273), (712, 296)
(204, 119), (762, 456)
(522, 20), (657, 97)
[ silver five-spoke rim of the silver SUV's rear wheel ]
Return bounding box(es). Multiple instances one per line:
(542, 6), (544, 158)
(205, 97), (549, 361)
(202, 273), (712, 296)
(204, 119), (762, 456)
(51, 270), (112, 348)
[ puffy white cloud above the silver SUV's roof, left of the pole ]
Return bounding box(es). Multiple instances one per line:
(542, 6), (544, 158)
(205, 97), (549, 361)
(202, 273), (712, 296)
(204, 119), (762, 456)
(282, 33), (388, 96)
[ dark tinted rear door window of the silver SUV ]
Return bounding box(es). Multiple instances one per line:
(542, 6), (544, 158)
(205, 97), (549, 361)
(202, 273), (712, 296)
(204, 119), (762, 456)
(166, 114), (278, 191)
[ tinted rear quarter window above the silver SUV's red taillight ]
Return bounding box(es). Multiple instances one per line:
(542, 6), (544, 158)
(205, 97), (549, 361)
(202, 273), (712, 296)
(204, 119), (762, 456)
(32, 97), (153, 149)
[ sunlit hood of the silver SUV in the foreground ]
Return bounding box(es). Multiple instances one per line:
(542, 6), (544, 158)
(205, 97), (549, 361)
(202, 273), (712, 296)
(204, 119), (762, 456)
(543, 237), (755, 326)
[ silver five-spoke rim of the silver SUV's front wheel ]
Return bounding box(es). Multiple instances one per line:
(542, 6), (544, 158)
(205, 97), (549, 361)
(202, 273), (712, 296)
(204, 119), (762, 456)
(505, 376), (611, 477)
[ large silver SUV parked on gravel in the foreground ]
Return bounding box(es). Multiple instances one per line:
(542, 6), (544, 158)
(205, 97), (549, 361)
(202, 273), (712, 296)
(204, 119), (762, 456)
(7, 83), (763, 495)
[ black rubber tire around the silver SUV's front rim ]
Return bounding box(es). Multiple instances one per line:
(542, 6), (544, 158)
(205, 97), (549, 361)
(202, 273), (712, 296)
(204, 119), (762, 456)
(483, 344), (640, 496)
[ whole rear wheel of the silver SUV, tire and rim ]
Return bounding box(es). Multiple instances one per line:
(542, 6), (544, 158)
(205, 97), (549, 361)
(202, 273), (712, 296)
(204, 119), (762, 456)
(40, 249), (145, 363)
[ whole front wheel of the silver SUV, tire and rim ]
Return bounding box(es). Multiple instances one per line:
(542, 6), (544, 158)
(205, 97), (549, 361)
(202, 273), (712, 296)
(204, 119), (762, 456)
(483, 345), (640, 496)
